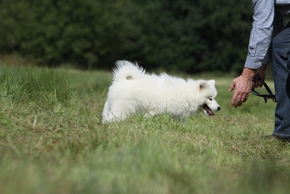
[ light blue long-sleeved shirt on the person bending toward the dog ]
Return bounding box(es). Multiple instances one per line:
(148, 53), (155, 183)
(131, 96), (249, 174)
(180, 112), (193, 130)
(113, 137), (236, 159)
(245, 0), (290, 69)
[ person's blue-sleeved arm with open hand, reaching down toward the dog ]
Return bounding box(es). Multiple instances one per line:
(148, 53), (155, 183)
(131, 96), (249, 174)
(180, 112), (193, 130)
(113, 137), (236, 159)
(229, 0), (275, 107)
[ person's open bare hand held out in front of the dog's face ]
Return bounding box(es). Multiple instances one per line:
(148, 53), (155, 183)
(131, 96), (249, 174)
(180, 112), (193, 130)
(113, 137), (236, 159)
(229, 68), (255, 107)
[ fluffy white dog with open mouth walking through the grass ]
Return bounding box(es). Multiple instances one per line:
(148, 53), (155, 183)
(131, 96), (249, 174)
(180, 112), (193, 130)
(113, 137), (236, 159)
(102, 61), (221, 123)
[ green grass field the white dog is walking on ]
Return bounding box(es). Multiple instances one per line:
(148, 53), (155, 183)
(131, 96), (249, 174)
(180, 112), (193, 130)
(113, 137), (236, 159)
(0, 65), (290, 194)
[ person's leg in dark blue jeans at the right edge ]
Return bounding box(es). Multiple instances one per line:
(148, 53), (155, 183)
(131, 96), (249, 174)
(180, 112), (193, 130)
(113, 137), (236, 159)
(272, 22), (290, 138)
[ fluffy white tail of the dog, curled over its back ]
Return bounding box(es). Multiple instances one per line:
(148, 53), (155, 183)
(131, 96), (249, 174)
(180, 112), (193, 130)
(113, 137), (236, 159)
(113, 61), (145, 82)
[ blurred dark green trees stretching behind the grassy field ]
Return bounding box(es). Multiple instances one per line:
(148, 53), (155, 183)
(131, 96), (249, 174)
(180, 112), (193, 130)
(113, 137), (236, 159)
(0, 0), (252, 73)
